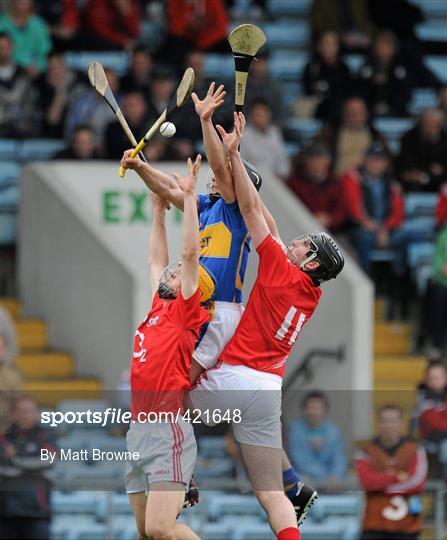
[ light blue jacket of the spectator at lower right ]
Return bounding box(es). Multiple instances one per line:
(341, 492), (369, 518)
(288, 420), (347, 482)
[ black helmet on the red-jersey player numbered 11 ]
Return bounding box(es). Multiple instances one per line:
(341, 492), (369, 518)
(289, 232), (345, 283)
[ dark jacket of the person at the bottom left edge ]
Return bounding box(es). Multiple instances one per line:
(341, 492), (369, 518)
(0, 424), (56, 519)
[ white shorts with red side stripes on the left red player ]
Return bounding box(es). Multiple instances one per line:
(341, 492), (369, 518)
(125, 419), (197, 493)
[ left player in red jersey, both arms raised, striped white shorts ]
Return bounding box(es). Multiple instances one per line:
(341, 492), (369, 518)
(125, 155), (209, 540)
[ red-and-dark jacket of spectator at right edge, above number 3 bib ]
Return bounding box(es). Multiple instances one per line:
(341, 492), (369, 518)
(413, 384), (447, 439)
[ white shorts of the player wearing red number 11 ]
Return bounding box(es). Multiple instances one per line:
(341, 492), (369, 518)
(189, 362), (282, 448)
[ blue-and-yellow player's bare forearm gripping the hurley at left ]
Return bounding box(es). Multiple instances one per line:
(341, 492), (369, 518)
(121, 150), (186, 210)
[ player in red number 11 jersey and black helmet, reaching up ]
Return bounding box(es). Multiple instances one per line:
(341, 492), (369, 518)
(189, 113), (344, 540)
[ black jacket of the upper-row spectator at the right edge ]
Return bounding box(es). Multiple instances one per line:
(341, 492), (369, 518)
(397, 126), (447, 192)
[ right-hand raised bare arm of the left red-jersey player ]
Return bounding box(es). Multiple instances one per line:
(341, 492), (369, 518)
(174, 154), (202, 300)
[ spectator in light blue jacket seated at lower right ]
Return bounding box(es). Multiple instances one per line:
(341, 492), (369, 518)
(288, 392), (348, 491)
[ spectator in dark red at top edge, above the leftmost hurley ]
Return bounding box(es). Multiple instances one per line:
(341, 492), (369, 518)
(83, 0), (140, 51)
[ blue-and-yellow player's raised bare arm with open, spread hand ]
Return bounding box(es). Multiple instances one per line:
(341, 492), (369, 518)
(191, 82), (236, 203)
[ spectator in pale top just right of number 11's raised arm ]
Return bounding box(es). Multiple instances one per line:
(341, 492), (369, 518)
(241, 99), (290, 179)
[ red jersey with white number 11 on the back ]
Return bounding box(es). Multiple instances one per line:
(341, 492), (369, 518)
(221, 234), (321, 377)
